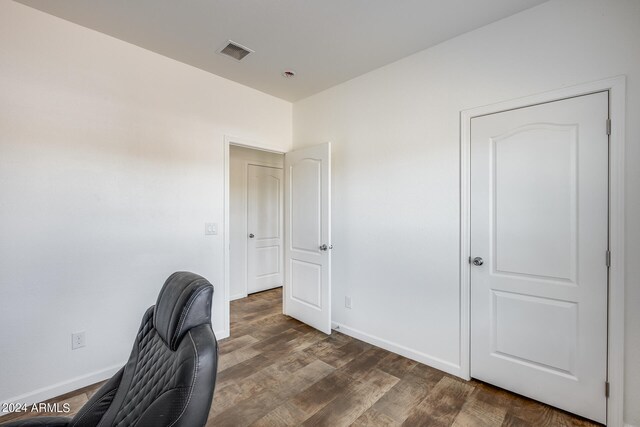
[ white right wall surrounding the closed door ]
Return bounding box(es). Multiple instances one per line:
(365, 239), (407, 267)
(293, 0), (640, 425)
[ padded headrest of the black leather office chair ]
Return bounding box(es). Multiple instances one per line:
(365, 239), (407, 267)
(153, 271), (213, 351)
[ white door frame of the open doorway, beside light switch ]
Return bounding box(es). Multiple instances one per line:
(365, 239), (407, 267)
(224, 135), (286, 339)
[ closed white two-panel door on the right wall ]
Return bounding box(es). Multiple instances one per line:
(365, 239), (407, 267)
(471, 92), (608, 423)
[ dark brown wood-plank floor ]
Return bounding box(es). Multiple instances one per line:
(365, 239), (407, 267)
(0, 289), (598, 427)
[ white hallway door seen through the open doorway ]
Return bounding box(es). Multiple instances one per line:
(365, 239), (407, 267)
(247, 165), (284, 293)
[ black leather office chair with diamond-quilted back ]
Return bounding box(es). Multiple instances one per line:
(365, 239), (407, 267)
(2, 272), (218, 427)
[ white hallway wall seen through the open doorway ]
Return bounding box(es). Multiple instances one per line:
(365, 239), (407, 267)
(229, 145), (284, 299)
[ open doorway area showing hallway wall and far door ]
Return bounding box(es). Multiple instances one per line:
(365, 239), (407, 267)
(229, 145), (284, 300)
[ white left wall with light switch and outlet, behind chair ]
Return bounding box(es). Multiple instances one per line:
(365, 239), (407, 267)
(0, 1), (292, 408)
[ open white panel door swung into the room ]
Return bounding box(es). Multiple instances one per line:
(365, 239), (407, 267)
(284, 143), (331, 334)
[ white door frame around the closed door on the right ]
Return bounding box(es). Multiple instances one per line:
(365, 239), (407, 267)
(460, 76), (626, 426)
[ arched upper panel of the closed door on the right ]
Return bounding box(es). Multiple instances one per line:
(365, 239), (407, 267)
(489, 123), (580, 283)
